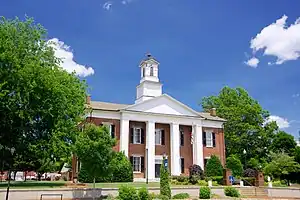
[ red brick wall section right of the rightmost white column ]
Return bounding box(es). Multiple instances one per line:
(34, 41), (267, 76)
(203, 127), (225, 166)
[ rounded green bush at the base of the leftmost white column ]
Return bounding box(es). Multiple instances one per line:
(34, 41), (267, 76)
(109, 152), (133, 182)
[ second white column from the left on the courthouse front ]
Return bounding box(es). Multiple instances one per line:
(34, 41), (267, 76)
(146, 121), (155, 180)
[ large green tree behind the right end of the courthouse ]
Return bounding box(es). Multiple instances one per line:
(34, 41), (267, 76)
(201, 87), (278, 163)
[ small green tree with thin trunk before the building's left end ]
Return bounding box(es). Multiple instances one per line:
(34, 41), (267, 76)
(74, 124), (116, 188)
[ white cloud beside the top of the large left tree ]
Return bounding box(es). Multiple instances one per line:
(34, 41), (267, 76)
(48, 38), (94, 77)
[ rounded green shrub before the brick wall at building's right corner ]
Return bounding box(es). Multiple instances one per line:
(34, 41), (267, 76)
(205, 155), (223, 176)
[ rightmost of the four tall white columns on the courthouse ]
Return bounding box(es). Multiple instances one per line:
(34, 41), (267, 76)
(192, 125), (204, 169)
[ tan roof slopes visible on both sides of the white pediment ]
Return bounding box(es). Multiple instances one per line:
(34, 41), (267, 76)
(90, 97), (226, 122)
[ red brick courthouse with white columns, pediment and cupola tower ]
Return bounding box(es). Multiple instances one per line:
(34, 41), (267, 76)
(77, 54), (225, 181)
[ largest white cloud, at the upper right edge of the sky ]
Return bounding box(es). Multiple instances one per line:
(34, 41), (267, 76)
(250, 15), (300, 65)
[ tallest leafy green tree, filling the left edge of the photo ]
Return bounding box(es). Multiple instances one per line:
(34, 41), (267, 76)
(0, 17), (86, 173)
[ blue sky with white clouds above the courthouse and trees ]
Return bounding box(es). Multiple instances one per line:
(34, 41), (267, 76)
(0, 0), (300, 138)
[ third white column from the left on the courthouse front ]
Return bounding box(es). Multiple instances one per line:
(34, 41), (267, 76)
(170, 123), (181, 176)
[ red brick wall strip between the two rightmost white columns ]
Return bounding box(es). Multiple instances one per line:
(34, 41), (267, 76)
(180, 126), (193, 175)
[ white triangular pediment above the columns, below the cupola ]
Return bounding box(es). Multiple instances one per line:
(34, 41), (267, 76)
(124, 94), (199, 117)
